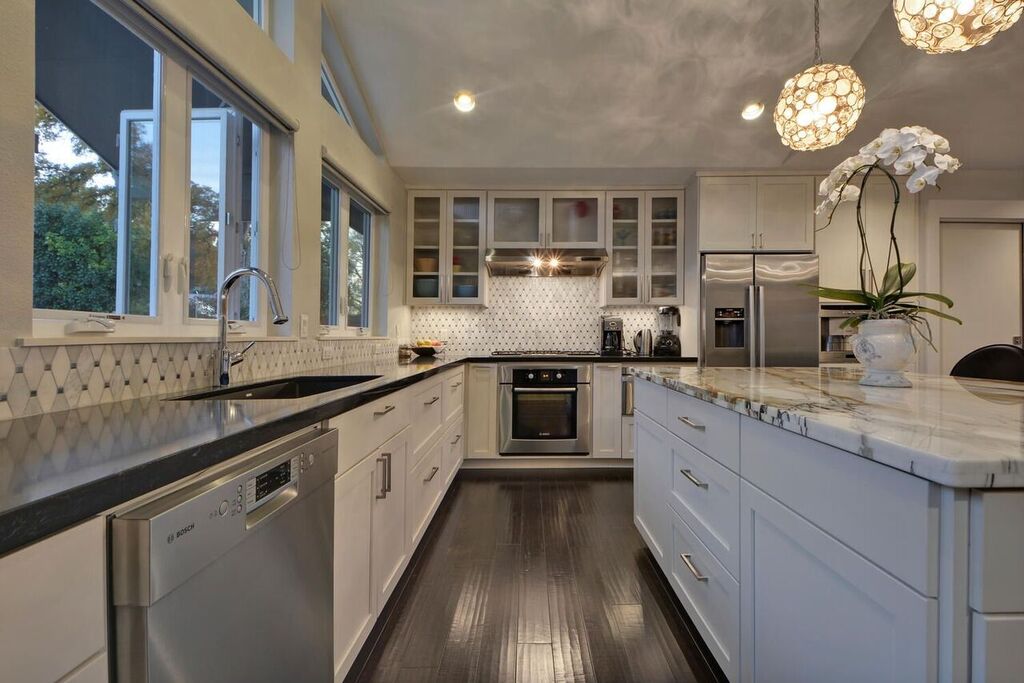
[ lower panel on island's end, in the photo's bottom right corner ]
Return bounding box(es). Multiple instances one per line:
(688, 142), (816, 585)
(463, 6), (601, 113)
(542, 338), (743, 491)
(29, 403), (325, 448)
(971, 612), (1024, 683)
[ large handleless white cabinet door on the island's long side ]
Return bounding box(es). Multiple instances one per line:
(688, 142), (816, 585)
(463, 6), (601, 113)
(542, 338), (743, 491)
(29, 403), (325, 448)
(739, 481), (938, 683)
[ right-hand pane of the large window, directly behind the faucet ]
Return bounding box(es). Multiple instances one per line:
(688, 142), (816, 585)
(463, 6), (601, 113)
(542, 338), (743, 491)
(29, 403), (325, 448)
(188, 79), (260, 321)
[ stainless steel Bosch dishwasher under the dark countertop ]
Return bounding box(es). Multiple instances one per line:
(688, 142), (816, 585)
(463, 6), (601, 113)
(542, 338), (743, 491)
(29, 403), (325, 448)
(112, 430), (338, 683)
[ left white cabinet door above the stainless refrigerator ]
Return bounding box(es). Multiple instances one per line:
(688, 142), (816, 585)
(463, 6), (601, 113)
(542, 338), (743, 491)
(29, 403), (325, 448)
(699, 177), (758, 251)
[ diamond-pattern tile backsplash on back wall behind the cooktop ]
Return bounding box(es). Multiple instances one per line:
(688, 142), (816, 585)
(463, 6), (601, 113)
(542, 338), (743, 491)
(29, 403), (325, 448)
(412, 278), (675, 353)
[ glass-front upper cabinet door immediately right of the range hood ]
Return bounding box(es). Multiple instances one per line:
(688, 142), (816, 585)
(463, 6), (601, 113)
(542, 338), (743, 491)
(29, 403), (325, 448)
(604, 193), (646, 304)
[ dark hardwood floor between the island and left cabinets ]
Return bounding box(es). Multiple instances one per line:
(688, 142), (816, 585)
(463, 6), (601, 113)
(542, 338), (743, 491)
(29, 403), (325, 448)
(348, 470), (724, 683)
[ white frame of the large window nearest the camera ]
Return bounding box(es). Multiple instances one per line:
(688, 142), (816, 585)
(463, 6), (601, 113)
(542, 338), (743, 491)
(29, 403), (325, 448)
(30, 7), (272, 344)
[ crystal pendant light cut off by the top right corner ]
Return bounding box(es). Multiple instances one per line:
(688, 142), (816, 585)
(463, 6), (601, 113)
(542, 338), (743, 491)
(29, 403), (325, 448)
(893, 0), (1024, 54)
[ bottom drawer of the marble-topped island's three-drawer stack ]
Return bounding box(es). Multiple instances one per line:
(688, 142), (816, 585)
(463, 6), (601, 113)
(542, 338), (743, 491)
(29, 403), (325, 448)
(671, 514), (739, 681)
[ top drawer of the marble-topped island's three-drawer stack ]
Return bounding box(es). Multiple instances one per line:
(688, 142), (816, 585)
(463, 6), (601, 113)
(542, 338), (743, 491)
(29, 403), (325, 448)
(665, 391), (739, 472)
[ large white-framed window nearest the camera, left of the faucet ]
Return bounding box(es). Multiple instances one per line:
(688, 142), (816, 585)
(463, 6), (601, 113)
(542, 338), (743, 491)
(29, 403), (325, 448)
(33, 0), (270, 337)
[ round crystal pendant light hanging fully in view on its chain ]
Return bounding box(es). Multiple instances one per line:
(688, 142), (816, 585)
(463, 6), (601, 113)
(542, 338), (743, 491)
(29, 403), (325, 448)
(774, 0), (864, 152)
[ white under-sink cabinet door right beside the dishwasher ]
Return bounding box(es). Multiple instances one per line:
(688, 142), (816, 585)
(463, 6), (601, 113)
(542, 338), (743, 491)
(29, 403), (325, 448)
(334, 454), (383, 680)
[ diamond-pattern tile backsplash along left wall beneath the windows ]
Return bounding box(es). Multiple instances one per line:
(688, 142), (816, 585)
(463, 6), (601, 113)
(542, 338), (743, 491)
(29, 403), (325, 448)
(0, 339), (398, 420)
